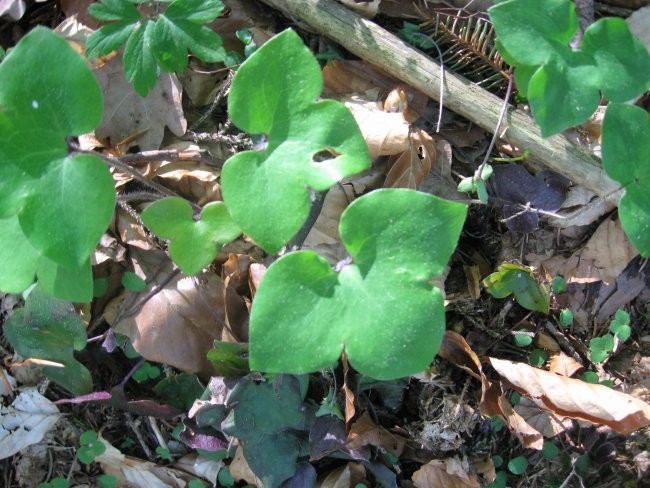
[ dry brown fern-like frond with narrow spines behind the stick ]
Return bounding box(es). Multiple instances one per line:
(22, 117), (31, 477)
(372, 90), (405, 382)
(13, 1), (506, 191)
(421, 12), (510, 93)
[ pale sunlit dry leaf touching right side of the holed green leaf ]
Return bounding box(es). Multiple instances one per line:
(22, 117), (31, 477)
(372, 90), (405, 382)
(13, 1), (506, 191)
(342, 96), (410, 159)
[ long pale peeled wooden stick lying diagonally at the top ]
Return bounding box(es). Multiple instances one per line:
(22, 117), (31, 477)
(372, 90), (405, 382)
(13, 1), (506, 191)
(262, 0), (622, 202)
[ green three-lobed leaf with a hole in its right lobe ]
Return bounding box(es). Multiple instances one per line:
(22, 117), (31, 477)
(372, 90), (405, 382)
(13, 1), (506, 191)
(221, 30), (370, 253)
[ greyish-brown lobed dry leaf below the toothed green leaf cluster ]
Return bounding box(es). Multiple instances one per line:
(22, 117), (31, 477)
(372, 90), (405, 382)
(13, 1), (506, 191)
(95, 57), (187, 151)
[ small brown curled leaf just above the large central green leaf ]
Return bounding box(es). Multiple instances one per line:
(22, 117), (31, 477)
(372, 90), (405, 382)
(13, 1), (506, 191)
(384, 130), (438, 190)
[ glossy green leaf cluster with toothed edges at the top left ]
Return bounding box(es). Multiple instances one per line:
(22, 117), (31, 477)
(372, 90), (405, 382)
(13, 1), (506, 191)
(86, 0), (226, 97)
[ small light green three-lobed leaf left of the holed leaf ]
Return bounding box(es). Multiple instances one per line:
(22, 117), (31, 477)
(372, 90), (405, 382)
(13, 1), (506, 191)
(142, 197), (241, 275)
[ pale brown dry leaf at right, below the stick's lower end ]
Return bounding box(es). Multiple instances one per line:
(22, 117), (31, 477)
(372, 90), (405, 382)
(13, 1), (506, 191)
(542, 216), (639, 283)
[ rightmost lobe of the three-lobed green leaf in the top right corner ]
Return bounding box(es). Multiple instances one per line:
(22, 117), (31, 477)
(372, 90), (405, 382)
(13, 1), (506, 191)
(580, 17), (650, 102)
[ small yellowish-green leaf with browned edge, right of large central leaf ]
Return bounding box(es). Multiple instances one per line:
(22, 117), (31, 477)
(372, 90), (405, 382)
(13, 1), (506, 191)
(483, 263), (550, 313)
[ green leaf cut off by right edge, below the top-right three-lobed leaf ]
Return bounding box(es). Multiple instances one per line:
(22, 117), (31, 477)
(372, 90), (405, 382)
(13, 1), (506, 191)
(602, 103), (650, 257)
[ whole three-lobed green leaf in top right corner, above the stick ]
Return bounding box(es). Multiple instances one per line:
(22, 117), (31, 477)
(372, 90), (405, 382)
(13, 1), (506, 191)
(489, 0), (650, 136)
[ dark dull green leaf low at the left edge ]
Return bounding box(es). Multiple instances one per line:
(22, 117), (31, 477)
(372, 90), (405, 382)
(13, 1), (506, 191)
(3, 288), (92, 395)
